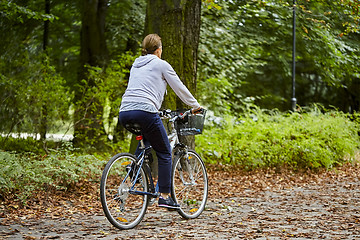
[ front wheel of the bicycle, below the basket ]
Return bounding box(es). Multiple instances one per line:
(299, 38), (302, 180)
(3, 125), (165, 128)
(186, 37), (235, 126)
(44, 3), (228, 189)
(171, 150), (208, 219)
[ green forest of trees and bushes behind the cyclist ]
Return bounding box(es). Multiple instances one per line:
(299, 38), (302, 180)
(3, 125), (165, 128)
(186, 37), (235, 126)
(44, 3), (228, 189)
(0, 0), (360, 202)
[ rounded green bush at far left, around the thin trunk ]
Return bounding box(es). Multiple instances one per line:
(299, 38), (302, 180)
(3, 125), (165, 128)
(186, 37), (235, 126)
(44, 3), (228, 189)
(0, 54), (70, 136)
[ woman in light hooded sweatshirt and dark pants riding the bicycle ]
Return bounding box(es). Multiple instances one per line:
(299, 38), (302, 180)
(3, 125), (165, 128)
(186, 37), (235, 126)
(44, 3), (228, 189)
(119, 34), (201, 209)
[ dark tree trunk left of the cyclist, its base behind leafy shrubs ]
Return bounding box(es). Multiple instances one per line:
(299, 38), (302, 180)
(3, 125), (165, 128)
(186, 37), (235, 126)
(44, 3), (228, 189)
(74, 0), (108, 147)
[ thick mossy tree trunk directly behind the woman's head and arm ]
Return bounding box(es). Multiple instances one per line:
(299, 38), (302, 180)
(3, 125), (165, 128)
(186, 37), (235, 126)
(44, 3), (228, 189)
(145, 0), (201, 147)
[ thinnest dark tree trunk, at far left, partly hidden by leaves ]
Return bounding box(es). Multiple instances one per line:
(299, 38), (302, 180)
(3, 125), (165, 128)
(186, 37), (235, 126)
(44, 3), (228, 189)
(39, 0), (50, 140)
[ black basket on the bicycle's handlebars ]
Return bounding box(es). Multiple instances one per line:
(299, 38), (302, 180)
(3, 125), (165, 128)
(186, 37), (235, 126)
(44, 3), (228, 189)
(175, 109), (206, 136)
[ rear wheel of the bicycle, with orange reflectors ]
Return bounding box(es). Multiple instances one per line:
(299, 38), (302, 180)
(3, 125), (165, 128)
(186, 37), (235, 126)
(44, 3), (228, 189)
(100, 153), (149, 229)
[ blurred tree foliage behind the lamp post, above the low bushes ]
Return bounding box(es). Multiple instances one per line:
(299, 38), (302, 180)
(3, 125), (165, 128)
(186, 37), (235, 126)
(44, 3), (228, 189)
(198, 0), (360, 115)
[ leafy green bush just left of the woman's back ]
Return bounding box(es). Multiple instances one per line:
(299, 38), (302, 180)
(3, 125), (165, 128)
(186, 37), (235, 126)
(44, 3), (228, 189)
(75, 51), (136, 150)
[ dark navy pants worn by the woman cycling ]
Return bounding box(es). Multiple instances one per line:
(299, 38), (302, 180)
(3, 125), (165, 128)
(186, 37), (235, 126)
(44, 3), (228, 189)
(119, 110), (172, 193)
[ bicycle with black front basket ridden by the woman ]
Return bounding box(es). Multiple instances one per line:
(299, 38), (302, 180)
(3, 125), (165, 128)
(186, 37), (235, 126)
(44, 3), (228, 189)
(100, 109), (208, 229)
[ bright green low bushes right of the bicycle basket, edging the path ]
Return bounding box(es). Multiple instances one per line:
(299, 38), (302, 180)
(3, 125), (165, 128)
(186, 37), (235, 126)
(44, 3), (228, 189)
(197, 105), (360, 169)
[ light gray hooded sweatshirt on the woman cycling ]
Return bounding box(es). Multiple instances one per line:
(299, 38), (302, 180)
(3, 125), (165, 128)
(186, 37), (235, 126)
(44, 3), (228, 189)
(120, 54), (200, 111)
